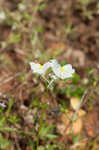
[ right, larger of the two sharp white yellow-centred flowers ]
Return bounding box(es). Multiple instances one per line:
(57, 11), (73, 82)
(50, 59), (75, 79)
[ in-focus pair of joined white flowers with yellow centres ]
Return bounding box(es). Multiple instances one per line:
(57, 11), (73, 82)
(29, 59), (75, 86)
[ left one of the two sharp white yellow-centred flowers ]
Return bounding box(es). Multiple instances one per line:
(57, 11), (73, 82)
(30, 62), (50, 75)
